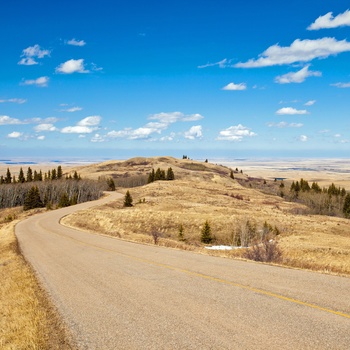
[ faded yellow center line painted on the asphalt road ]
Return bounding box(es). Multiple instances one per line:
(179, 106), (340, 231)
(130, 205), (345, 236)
(55, 227), (350, 319)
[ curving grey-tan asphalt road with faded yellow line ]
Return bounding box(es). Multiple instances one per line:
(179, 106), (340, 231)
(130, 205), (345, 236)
(16, 193), (350, 350)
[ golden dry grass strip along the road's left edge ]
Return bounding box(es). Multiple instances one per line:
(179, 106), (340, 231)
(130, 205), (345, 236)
(0, 208), (72, 350)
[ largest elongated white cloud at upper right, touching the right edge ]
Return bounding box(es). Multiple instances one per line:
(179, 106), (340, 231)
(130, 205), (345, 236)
(235, 38), (350, 68)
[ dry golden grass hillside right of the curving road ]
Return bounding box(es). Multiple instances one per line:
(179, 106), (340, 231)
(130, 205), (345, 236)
(64, 157), (350, 275)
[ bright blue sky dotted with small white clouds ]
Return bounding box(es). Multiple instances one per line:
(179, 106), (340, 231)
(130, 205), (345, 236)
(0, 0), (350, 160)
